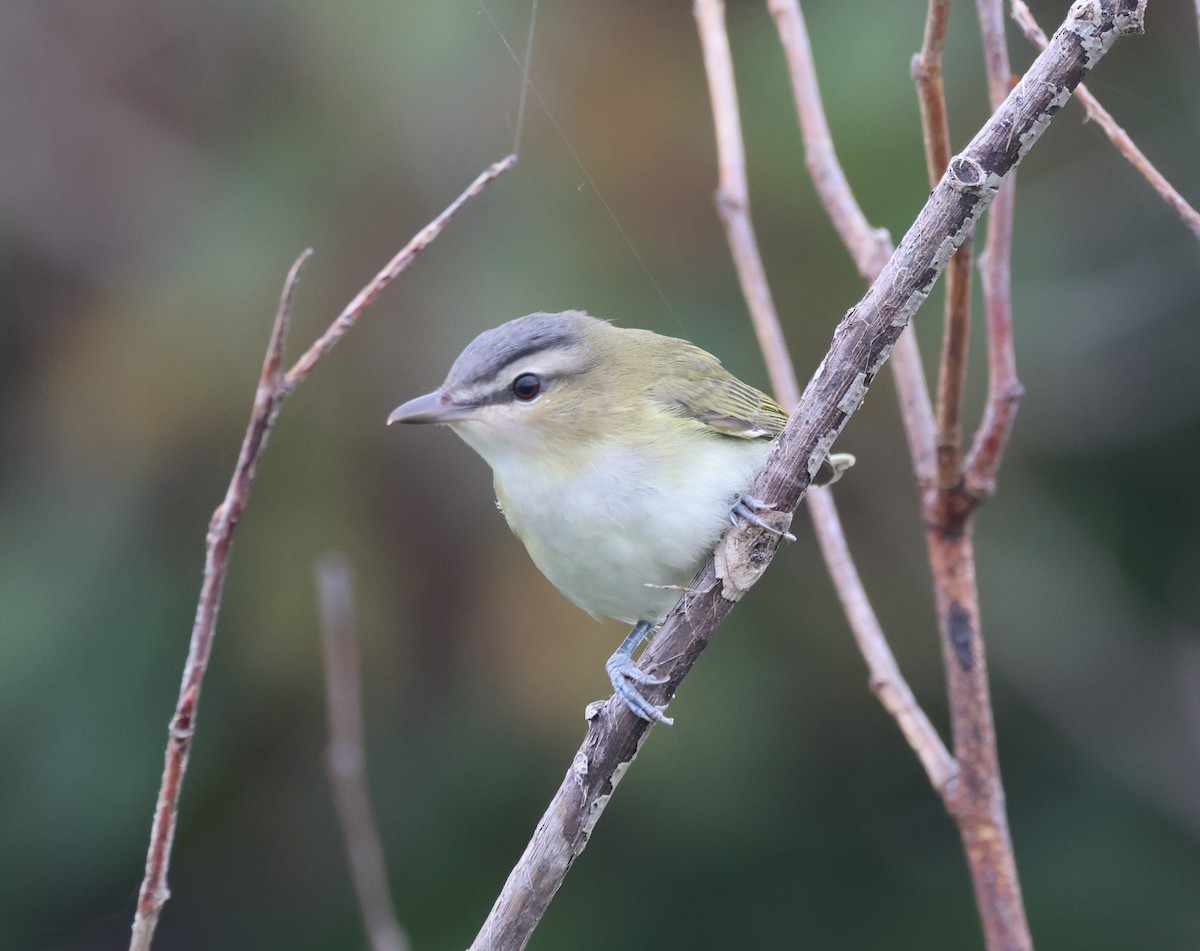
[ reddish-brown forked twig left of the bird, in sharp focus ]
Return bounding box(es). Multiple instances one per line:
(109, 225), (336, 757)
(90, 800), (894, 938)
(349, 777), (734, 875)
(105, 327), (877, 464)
(130, 155), (516, 951)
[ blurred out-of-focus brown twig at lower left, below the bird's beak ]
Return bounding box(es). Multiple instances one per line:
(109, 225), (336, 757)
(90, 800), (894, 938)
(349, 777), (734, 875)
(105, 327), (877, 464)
(316, 552), (409, 951)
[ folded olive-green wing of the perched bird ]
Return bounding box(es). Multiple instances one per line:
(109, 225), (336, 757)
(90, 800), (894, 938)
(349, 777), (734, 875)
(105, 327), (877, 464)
(649, 346), (787, 439)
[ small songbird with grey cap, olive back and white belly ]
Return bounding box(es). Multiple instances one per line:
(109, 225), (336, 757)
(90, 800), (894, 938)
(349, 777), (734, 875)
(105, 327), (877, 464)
(388, 311), (854, 723)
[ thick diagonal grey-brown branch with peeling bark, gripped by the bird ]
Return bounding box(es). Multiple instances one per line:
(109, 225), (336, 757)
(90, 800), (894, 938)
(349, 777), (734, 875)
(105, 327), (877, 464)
(472, 0), (1141, 951)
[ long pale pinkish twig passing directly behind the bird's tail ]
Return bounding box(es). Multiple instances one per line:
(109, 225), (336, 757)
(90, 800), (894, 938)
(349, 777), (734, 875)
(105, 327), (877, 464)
(695, 0), (954, 788)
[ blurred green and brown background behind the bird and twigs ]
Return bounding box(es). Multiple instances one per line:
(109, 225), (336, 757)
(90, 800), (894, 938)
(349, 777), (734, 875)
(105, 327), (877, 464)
(0, 0), (1200, 951)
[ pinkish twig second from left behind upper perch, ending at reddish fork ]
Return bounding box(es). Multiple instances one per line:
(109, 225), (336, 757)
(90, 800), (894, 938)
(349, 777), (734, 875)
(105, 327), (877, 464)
(767, 0), (935, 491)
